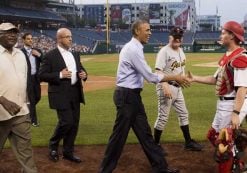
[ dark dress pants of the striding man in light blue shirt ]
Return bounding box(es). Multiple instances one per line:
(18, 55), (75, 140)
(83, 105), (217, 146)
(99, 88), (168, 173)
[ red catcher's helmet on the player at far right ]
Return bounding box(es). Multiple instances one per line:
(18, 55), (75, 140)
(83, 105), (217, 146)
(223, 21), (244, 42)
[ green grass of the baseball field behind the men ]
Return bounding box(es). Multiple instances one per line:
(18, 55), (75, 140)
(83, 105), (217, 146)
(4, 53), (225, 146)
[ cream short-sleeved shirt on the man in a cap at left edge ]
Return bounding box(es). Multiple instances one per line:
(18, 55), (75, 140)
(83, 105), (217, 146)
(0, 45), (29, 121)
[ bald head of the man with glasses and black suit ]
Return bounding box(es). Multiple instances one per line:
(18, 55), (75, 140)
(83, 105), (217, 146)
(56, 28), (72, 50)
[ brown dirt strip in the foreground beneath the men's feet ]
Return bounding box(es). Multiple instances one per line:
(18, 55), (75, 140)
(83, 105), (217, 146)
(0, 143), (217, 173)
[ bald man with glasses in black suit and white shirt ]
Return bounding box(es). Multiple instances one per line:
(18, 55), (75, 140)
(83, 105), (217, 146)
(39, 28), (87, 163)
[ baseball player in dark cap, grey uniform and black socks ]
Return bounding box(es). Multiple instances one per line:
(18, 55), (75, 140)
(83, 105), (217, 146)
(154, 27), (203, 151)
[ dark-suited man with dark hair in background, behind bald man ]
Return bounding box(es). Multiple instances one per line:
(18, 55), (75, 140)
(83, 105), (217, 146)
(21, 33), (43, 127)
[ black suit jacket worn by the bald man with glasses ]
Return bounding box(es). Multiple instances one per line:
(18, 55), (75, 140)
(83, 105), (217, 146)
(39, 48), (87, 109)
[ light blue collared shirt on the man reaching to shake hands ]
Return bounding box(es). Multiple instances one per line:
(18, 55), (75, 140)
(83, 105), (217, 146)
(116, 38), (164, 89)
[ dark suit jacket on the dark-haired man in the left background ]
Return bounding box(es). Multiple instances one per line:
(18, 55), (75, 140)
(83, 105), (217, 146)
(21, 47), (43, 104)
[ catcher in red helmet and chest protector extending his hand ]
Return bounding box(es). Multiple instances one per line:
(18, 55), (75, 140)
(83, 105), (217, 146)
(189, 21), (247, 173)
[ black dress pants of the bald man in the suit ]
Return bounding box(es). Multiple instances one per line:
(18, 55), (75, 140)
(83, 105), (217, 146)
(49, 86), (80, 155)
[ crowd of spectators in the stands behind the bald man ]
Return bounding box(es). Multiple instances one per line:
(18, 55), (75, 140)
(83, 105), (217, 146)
(16, 33), (90, 54)
